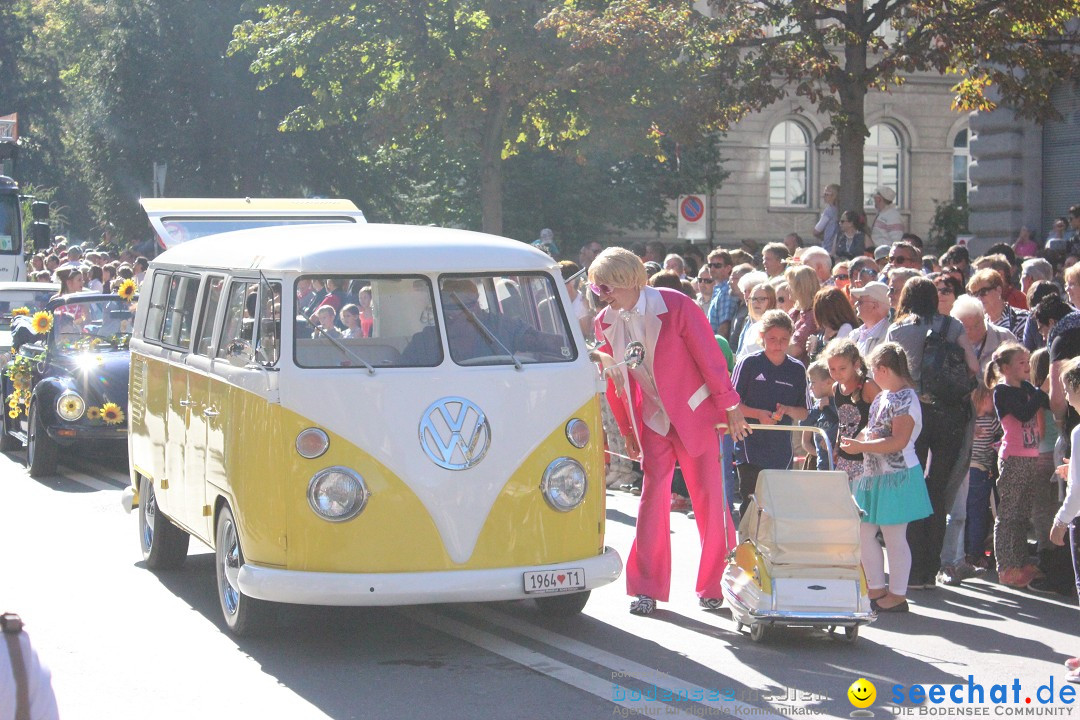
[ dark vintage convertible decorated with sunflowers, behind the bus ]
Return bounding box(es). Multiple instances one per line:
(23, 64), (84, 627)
(0, 294), (135, 477)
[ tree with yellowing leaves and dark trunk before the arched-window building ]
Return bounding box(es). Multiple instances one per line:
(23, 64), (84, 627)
(543, 0), (1080, 213)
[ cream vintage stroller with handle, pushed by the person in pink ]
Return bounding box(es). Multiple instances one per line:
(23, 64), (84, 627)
(723, 425), (876, 642)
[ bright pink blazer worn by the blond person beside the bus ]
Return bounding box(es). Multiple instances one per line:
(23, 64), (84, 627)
(595, 287), (739, 456)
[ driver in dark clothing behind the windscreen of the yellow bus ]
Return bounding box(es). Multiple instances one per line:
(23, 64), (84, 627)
(402, 279), (572, 365)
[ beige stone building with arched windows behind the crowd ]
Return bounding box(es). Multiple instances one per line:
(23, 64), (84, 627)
(617, 73), (969, 246)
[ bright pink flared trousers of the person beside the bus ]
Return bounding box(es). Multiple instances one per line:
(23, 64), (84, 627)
(626, 427), (735, 601)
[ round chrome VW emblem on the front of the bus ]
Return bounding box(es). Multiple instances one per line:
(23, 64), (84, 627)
(420, 397), (491, 470)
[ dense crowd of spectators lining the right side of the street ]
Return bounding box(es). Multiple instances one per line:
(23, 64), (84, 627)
(557, 198), (1080, 681)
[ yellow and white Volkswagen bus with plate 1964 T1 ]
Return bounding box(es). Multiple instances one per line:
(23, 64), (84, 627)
(127, 216), (622, 634)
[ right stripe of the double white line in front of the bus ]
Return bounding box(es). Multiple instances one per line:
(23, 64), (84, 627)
(464, 606), (783, 718)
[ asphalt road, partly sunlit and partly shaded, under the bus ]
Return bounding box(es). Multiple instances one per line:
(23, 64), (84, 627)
(0, 456), (1080, 720)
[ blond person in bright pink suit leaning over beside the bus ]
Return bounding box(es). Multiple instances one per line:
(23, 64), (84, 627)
(589, 247), (748, 615)
